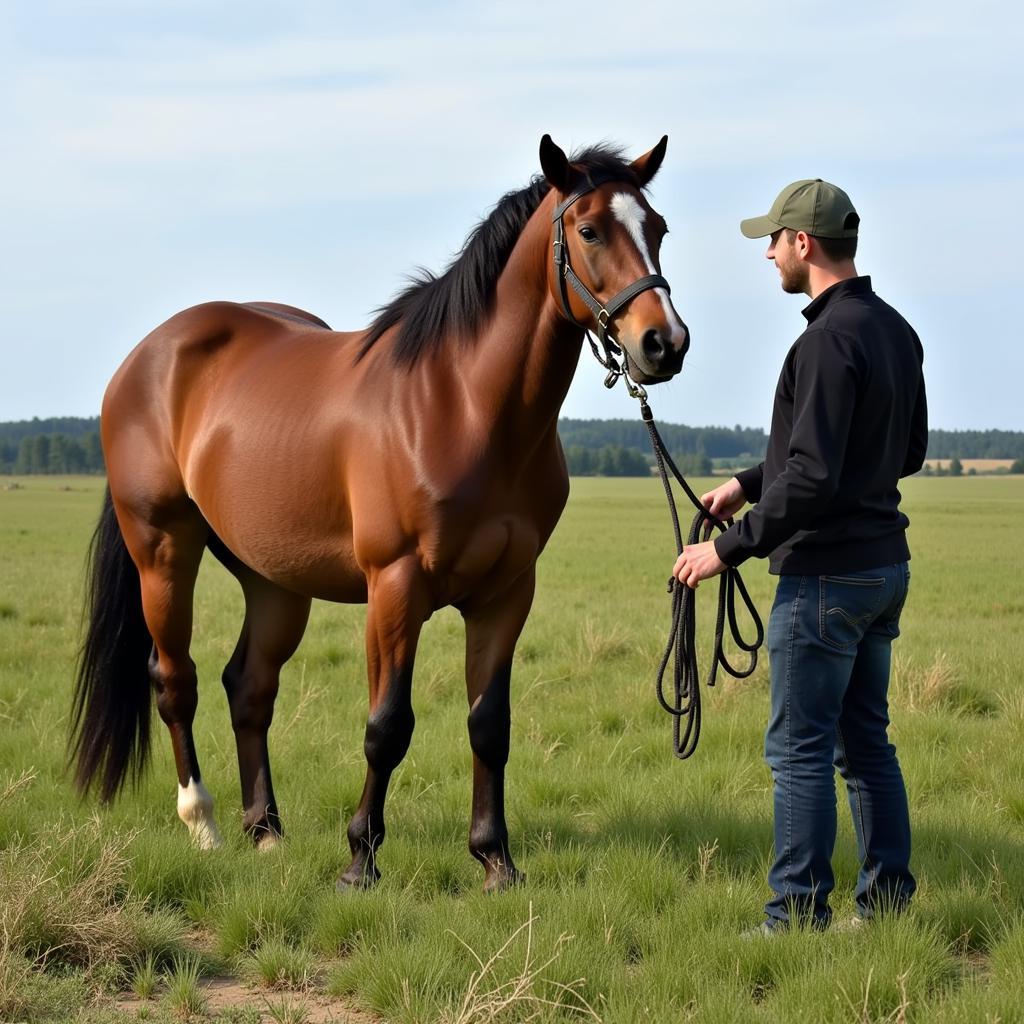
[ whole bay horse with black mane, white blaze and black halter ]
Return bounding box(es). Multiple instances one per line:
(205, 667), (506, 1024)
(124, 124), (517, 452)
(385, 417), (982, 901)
(70, 135), (689, 891)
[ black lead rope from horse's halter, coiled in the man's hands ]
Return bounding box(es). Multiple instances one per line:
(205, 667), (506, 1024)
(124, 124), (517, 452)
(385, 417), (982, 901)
(586, 331), (765, 761)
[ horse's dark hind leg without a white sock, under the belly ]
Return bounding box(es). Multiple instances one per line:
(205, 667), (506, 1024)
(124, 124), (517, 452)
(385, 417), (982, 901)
(223, 565), (310, 849)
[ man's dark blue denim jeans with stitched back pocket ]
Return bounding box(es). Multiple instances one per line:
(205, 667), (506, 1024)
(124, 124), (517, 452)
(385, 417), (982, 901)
(765, 562), (916, 928)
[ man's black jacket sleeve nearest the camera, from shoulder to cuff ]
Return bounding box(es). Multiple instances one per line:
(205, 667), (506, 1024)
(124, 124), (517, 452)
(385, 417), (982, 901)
(715, 330), (861, 565)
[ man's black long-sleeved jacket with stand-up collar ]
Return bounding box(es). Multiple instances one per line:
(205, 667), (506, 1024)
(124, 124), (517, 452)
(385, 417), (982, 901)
(715, 278), (928, 574)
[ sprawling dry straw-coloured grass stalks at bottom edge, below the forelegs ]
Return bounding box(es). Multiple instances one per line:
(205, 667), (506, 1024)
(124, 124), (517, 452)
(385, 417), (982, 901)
(438, 903), (601, 1024)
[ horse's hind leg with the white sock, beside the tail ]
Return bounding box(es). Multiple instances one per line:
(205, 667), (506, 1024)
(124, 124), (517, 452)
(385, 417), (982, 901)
(115, 495), (220, 849)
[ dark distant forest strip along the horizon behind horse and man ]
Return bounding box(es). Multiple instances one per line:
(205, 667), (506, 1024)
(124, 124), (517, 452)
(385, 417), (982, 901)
(0, 417), (1024, 476)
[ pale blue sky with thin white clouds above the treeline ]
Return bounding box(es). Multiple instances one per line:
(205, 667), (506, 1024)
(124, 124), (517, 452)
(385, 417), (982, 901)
(0, 0), (1024, 430)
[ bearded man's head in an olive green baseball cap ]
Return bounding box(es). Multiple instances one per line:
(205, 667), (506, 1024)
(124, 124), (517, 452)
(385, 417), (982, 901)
(739, 178), (860, 296)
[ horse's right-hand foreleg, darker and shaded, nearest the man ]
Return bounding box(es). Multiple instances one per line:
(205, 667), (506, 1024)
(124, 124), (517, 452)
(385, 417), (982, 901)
(463, 567), (535, 892)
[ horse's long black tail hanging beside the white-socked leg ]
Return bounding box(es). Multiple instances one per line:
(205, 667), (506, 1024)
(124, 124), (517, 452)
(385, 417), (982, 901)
(69, 487), (153, 803)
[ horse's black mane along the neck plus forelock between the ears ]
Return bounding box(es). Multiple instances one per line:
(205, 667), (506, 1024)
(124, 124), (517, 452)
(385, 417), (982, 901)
(357, 145), (638, 367)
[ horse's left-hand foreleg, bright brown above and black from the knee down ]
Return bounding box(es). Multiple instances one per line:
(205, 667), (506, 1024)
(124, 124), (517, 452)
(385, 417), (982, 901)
(338, 558), (431, 889)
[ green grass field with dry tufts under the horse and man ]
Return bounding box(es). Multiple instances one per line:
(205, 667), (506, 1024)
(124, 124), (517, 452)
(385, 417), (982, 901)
(0, 477), (1024, 1024)
